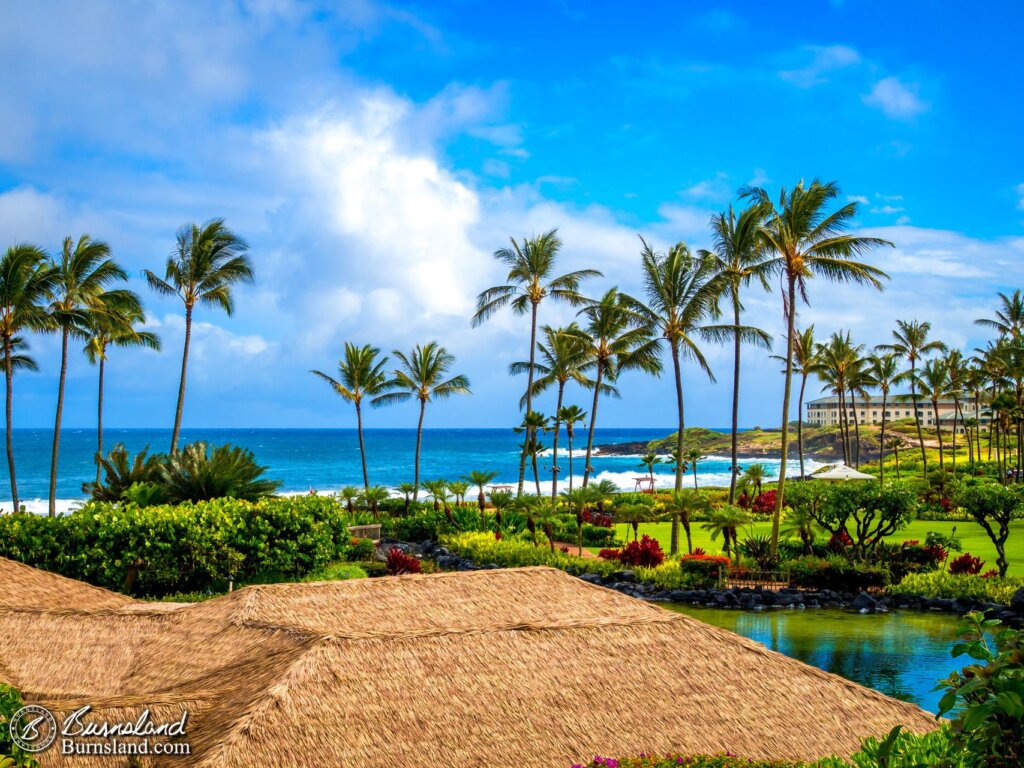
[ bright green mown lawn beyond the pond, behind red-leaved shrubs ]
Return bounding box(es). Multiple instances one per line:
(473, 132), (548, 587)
(616, 520), (1024, 575)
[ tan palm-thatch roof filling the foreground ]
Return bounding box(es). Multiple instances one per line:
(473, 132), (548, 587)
(0, 559), (936, 768)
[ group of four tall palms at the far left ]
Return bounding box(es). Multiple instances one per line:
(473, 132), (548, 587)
(0, 219), (253, 516)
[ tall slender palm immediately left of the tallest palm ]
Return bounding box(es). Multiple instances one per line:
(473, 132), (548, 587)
(700, 204), (771, 504)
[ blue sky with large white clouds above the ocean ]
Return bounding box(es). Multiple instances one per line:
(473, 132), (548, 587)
(0, 0), (1024, 428)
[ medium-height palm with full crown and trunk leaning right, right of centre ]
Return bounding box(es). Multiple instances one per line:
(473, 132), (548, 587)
(578, 288), (662, 487)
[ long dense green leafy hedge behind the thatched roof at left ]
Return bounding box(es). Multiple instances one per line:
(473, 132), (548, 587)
(0, 497), (349, 596)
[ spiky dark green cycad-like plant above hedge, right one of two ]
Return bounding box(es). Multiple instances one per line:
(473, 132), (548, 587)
(157, 441), (281, 504)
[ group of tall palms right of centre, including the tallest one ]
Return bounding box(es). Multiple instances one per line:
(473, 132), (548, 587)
(473, 180), (892, 552)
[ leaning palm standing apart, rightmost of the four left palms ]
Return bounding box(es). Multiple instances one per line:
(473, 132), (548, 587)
(143, 219), (253, 454)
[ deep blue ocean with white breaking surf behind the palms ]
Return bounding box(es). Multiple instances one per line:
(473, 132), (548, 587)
(0, 428), (818, 512)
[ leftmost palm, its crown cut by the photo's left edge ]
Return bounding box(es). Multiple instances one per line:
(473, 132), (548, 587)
(0, 243), (56, 512)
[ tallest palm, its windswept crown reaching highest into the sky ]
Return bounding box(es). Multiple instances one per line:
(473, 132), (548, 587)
(740, 179), (892, 558)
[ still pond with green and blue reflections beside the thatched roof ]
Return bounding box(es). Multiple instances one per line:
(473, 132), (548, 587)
(666, 604), (964, 712)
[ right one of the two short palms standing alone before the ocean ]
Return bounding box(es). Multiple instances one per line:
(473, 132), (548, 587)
(371, 341), (470, 500)
